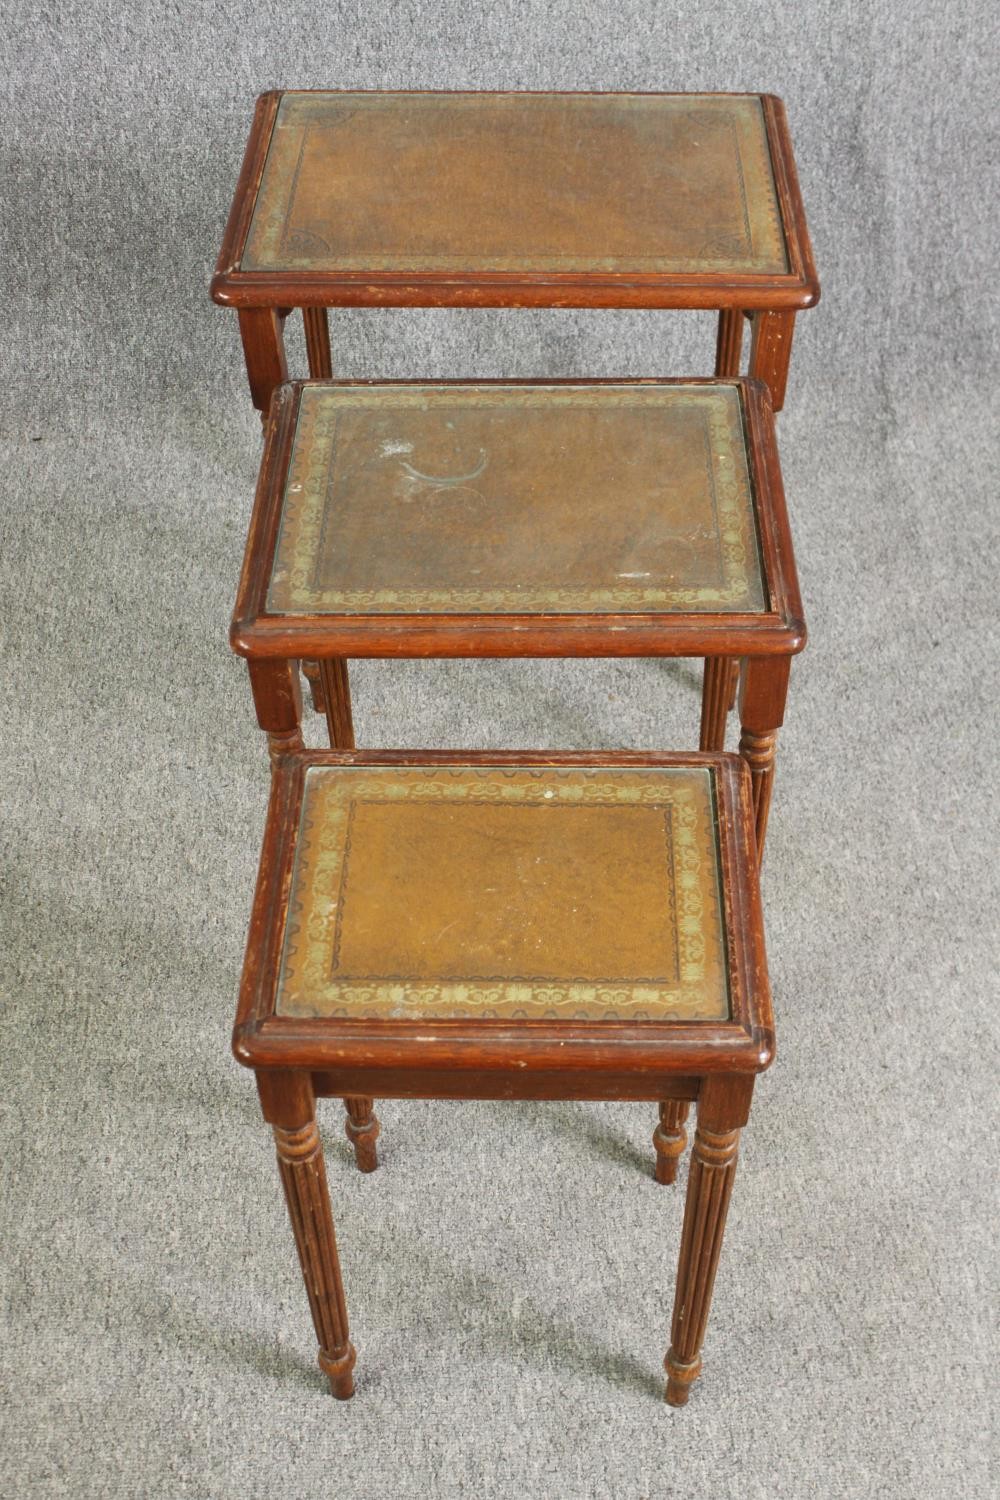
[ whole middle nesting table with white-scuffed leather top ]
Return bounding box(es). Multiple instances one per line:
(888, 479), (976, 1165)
(231, 378), (805, 849)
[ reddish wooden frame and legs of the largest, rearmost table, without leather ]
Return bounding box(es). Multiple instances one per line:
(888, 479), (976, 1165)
(211, 90), (820, 416)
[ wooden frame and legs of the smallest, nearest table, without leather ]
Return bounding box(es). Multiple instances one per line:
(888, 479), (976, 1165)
(232, 747), (774, 1406)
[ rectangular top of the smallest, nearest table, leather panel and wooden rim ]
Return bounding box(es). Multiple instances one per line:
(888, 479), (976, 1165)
(241, 752), (766, 1080)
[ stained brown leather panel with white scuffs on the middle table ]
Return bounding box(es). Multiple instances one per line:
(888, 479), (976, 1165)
(267, 386), (766, 615)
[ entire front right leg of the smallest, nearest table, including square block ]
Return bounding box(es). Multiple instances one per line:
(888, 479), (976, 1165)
(664, 1074), (753, 1406)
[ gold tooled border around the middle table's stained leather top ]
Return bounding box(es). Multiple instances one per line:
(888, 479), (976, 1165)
(267, 386), (768, 615)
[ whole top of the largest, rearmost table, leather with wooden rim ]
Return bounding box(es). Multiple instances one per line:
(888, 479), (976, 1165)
(213, 92), (819, 308)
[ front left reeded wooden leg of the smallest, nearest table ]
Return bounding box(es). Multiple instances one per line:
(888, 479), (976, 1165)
(258, 1073), (357, 1401)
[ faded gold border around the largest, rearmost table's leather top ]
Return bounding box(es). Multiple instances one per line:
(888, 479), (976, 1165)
(241, 92), (789, 276)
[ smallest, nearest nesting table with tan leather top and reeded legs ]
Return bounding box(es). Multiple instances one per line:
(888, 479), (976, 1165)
(234, 752), (774, 1406)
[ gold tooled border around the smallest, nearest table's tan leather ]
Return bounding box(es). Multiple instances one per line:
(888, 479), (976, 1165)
(276, 767), (730, 1022)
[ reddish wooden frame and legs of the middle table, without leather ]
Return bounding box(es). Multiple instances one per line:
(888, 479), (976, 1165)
(231, 378), (805, 854)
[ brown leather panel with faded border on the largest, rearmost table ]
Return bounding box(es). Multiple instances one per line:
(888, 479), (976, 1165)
(241, 93), (787, 275)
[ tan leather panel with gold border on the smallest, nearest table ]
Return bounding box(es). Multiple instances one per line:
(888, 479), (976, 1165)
(277, 767), (729, 1020)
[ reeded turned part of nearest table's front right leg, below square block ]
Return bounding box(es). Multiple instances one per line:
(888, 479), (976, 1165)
(664, 1125), (739, 1406)
